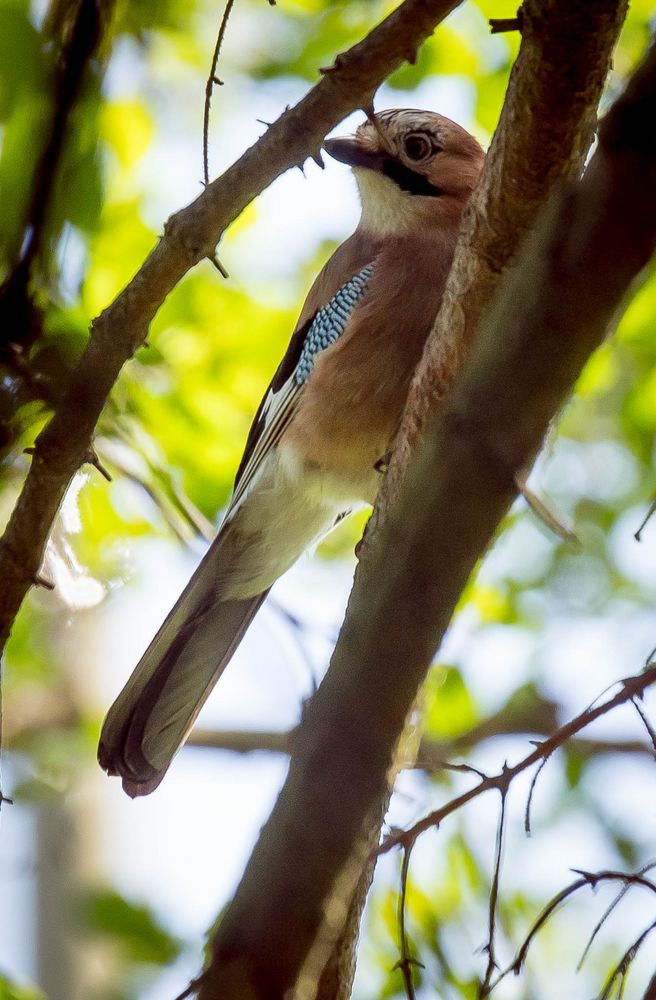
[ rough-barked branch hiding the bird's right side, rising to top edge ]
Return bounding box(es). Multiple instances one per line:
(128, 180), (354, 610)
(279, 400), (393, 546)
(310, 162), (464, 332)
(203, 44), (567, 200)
(379, 0), (627, 516)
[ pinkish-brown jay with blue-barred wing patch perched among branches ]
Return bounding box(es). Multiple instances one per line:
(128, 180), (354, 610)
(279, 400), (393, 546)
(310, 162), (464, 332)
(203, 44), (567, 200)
(98, 109), (484, 797)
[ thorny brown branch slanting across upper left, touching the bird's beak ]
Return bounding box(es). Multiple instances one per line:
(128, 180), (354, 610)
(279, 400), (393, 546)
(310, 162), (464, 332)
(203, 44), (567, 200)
(0, 0), (461, 650)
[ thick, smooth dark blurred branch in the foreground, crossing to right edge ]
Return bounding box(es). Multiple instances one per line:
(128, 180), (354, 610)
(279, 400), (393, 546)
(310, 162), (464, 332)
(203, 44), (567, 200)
(199, 21), (656, 1000)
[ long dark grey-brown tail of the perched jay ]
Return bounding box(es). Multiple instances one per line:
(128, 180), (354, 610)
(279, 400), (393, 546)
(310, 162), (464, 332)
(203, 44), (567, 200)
(98, 539), (268, 797)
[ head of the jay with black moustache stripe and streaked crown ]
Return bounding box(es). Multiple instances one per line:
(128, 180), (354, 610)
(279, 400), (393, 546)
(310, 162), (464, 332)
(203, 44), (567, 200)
(324, 109), (485, 236)
